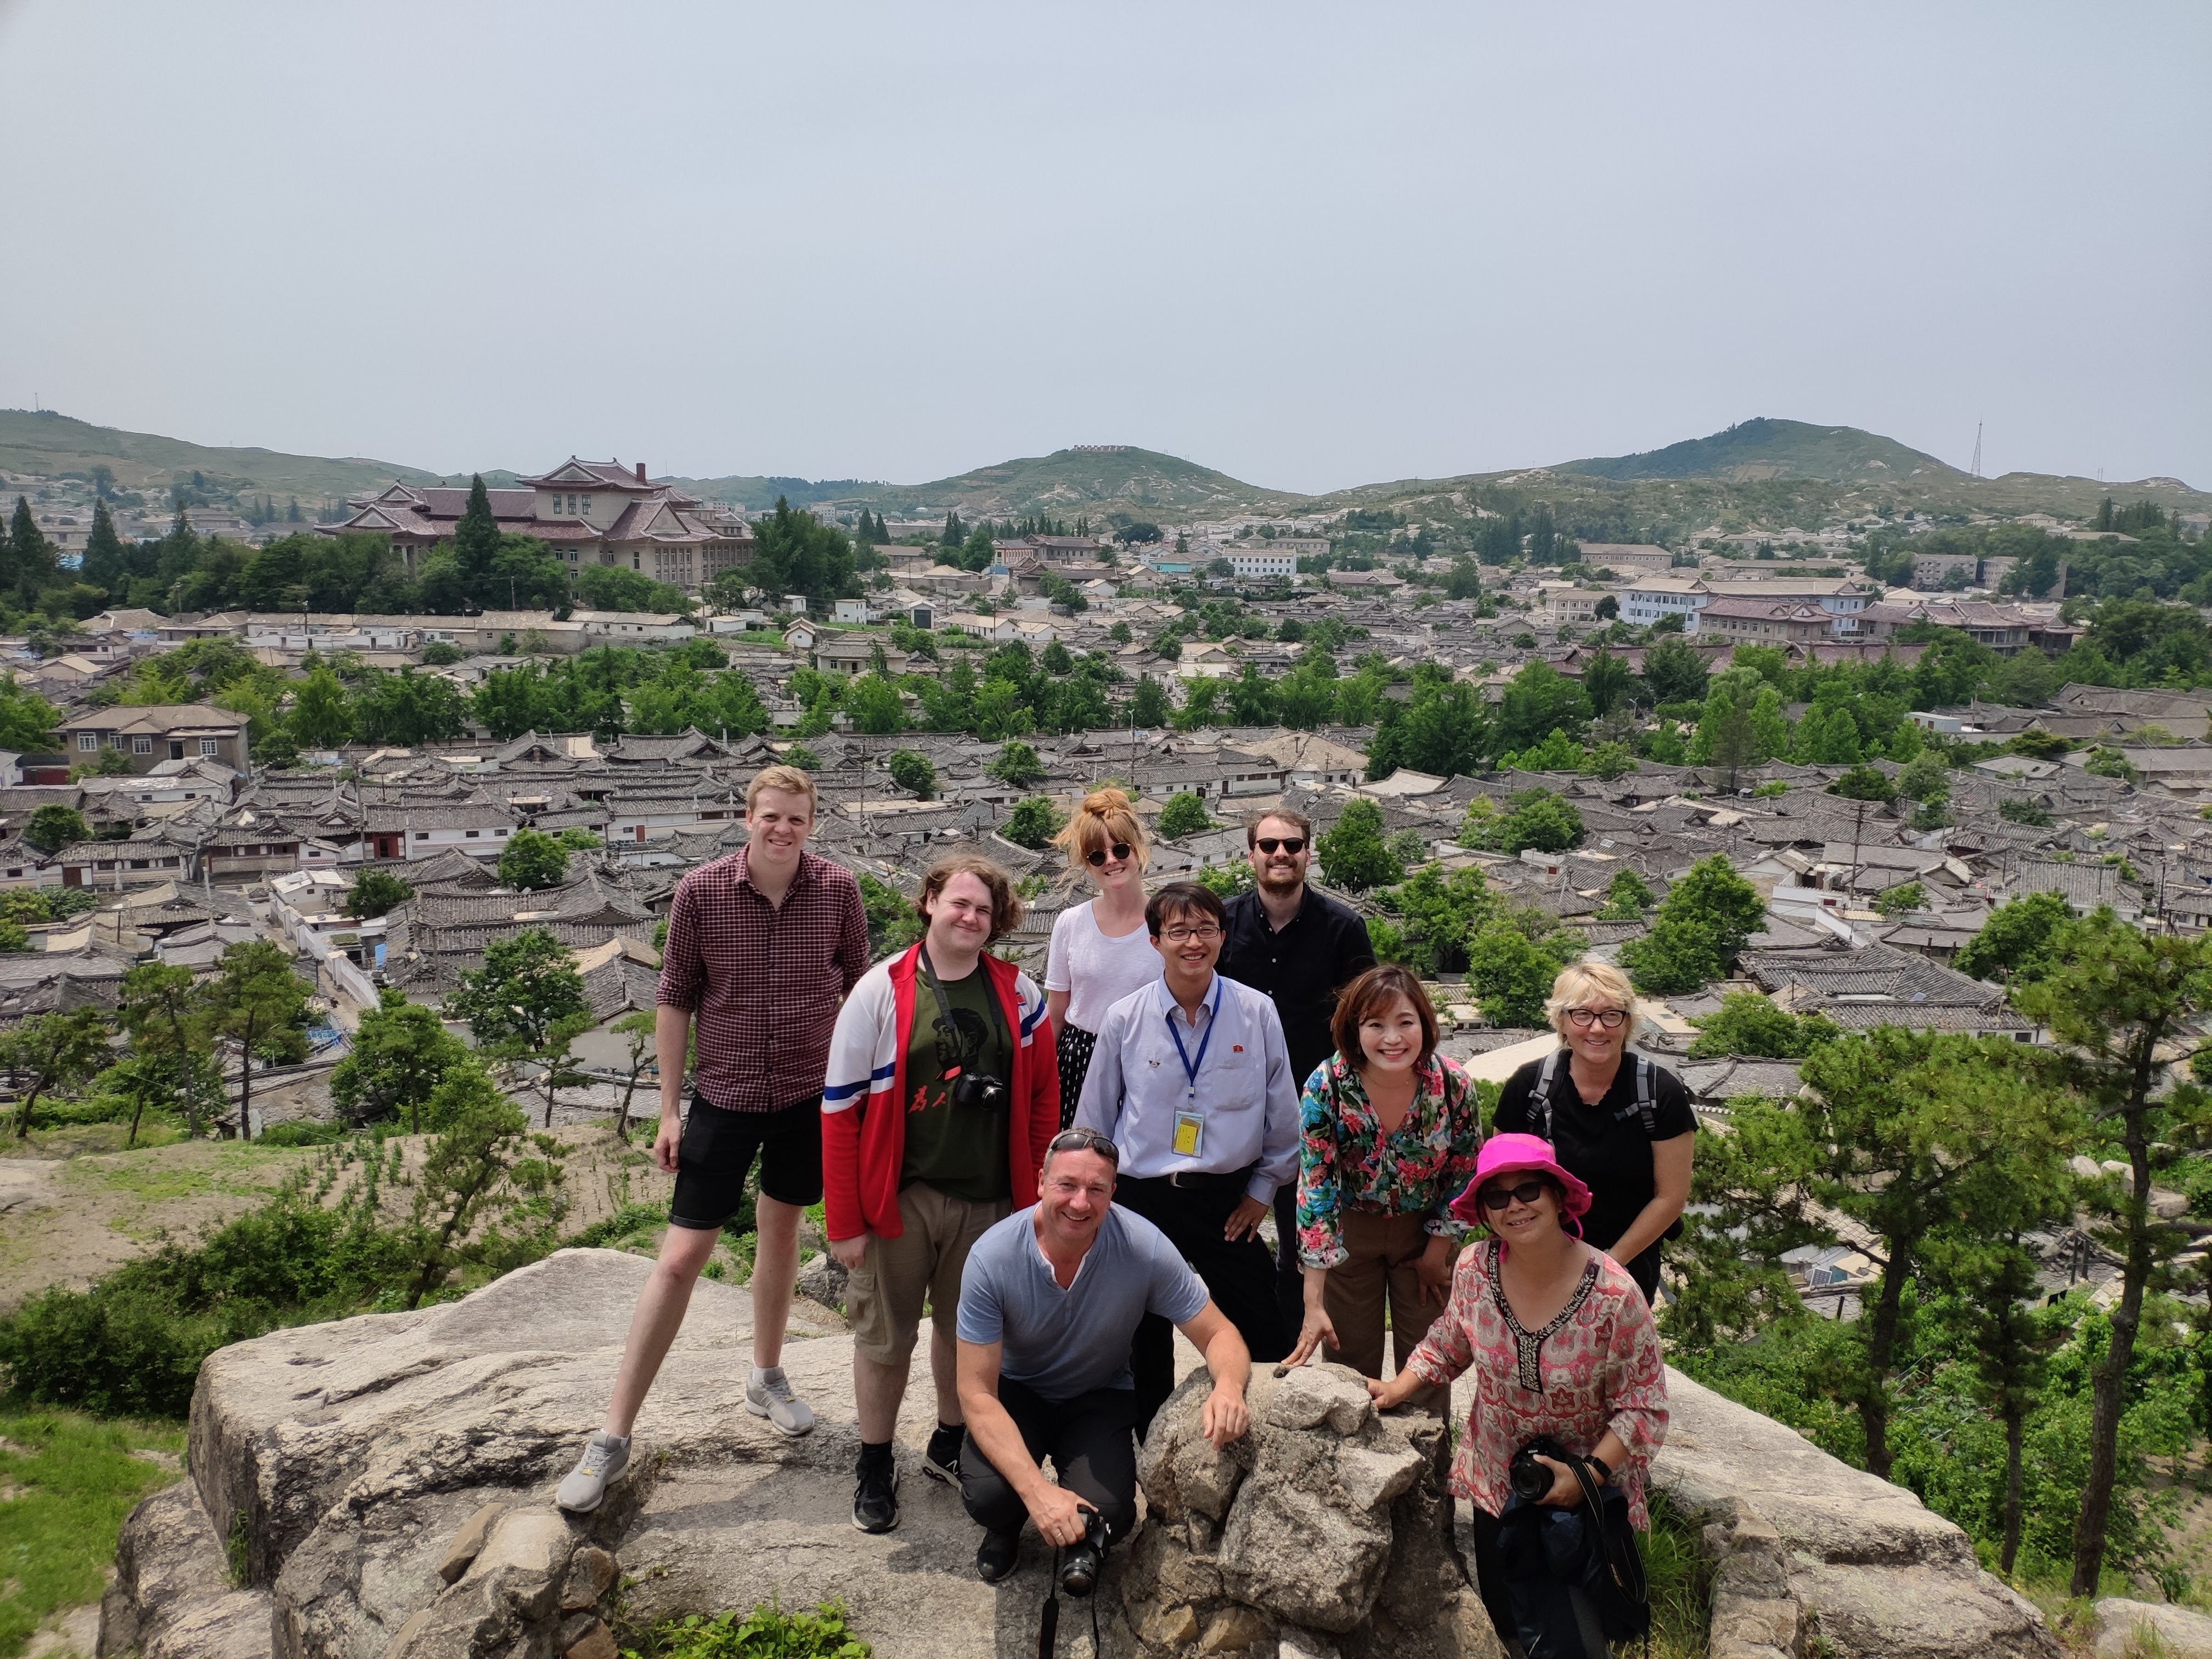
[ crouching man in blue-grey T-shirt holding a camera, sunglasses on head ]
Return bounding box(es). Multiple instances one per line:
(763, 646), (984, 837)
(958, 1128), (1252, 1584)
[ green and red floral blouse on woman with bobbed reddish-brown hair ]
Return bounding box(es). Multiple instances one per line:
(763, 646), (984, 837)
(1299, 1055), (1482, 1267)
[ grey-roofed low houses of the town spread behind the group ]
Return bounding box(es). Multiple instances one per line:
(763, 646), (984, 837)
(0, 484), (2212, 1327)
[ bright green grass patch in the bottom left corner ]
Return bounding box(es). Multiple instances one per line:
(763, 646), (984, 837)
(0, 1400), (184, 1659)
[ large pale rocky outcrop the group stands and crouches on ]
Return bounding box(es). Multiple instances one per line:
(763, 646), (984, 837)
(99, 1250), (2057, 1659)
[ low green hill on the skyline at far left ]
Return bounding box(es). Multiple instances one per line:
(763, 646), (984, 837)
(0, 409), (438, 504)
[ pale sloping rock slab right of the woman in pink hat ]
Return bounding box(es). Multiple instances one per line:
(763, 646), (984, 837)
(1652, 1372), (2062, 1659)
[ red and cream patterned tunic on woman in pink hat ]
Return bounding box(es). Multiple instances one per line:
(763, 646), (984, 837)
(1407, 1239), (1668, 1528)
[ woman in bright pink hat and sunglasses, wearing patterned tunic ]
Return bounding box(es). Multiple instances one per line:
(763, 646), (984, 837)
(1367, 1135), (1668, 1639)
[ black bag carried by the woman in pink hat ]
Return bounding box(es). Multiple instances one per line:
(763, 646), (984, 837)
(1498, 1438), (1652, 1659)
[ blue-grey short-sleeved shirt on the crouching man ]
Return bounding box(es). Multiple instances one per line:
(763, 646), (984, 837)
(958, 1203), (1205, 1400)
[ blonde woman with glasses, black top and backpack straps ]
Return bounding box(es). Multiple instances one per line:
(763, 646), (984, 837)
(1493, 962), (1697, 1303)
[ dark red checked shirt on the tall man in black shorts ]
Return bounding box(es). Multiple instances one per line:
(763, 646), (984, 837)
(659, 847), (867, 1113)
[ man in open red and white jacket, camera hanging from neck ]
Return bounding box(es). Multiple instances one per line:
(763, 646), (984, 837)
(823, 856), (1059, 1533)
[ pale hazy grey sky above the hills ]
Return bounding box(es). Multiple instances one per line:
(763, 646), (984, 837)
(0, 0), (2212, 491)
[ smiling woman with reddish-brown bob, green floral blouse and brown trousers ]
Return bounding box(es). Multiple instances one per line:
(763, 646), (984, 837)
(1290, 967), (1482, 1415)
